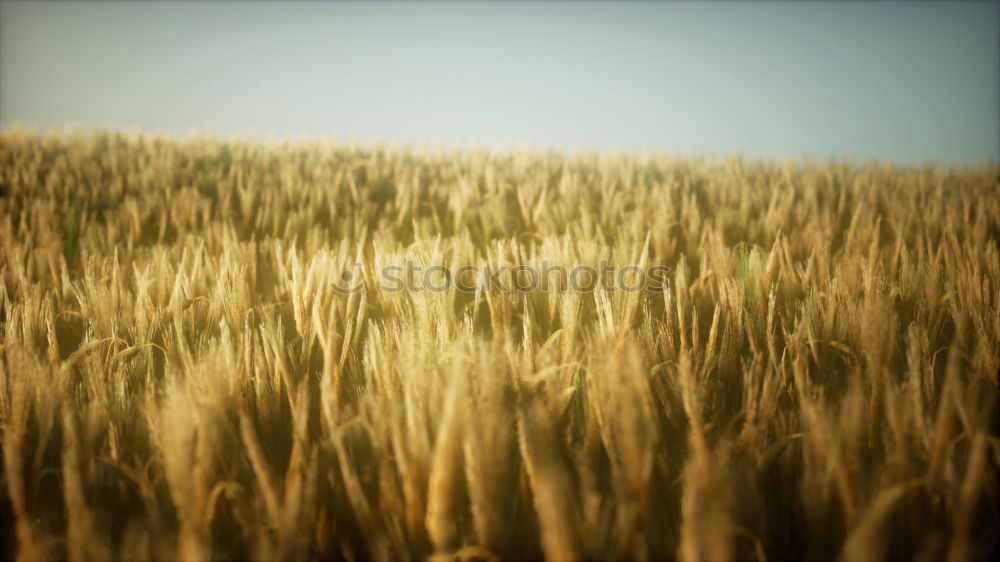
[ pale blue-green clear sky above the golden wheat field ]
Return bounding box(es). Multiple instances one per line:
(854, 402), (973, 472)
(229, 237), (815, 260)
(0, 0), (1000, 163)
